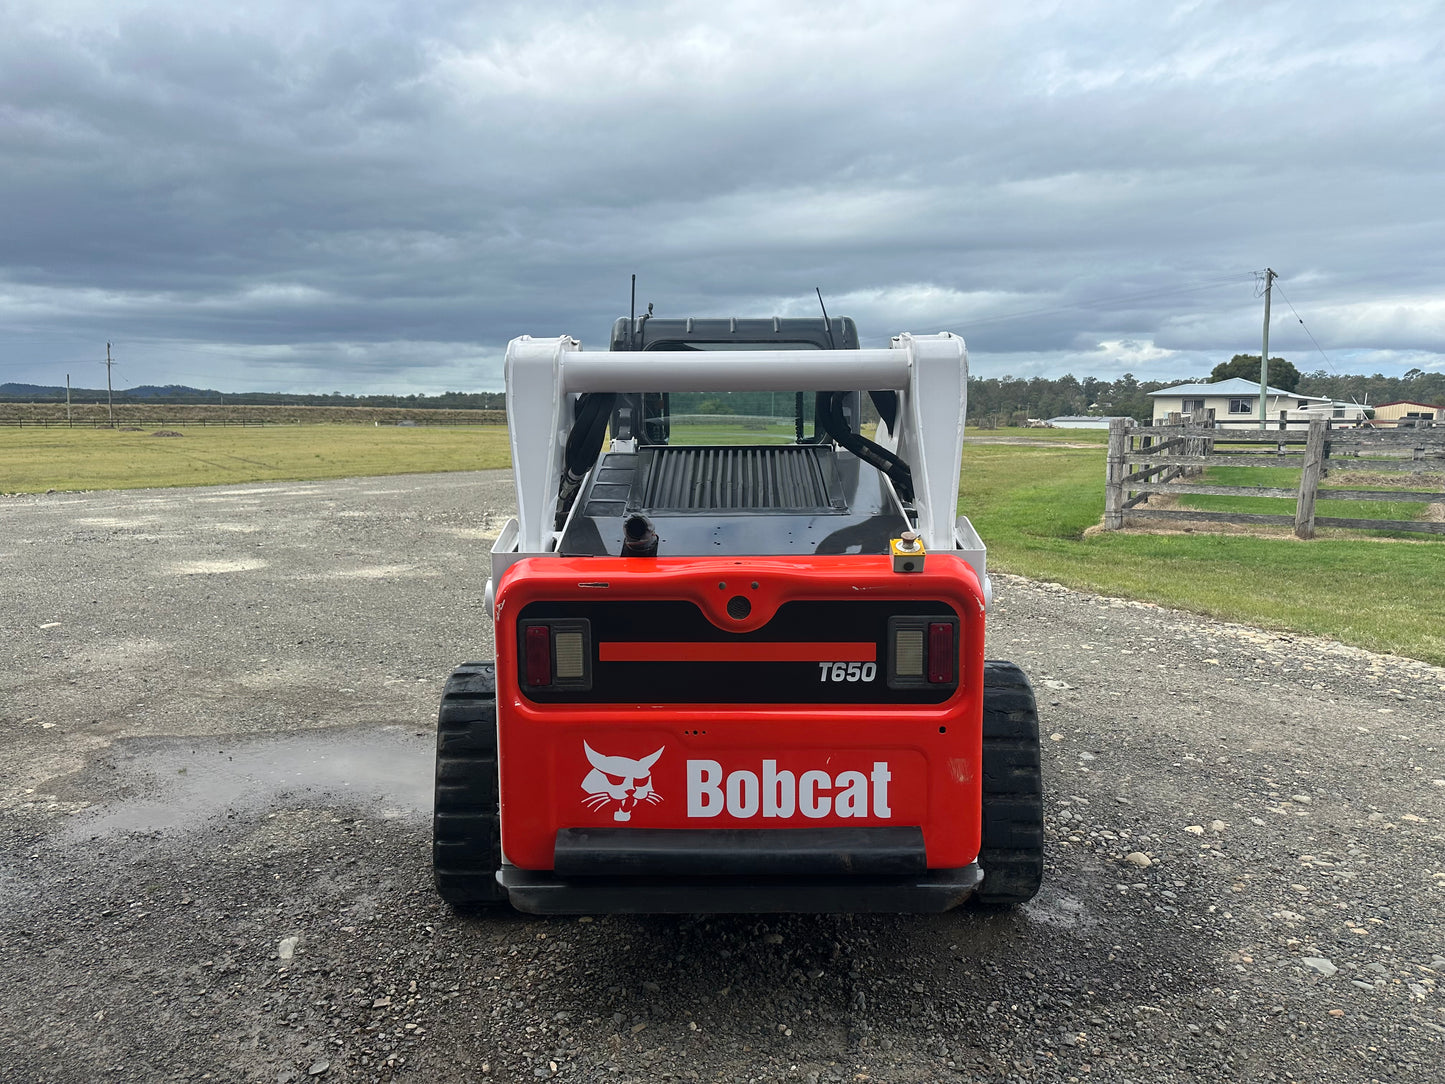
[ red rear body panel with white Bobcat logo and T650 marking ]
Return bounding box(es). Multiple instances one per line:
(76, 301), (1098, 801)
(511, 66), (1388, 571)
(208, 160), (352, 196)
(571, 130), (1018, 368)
(496, 554), (984, 870)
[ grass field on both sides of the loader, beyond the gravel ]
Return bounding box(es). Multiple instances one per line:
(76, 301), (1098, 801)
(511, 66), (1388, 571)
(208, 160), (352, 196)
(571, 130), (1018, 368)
(0, 425), (1445, 665)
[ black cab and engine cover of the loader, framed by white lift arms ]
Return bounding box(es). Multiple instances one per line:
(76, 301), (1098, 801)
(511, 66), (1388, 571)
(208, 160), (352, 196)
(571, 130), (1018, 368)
(558, 317), (912, 556)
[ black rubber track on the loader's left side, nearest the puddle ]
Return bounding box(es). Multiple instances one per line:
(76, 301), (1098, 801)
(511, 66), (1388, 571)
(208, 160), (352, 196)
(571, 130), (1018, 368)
(432, 662), (506, 906)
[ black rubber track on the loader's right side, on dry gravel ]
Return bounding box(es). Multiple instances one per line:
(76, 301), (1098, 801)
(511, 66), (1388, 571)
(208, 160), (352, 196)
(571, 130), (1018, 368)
(975, 661), (1043, 905)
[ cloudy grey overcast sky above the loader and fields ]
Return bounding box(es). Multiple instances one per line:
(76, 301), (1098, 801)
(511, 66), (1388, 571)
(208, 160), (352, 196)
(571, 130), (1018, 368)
(0, 0), (1445, 393)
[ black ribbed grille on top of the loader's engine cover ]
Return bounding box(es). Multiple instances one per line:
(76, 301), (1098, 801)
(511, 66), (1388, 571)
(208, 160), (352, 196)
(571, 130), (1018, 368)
(629, 445), (847, 515)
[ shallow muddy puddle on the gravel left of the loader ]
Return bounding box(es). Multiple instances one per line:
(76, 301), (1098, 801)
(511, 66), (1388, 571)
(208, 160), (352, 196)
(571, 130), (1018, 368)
(65, 727), (435, 843)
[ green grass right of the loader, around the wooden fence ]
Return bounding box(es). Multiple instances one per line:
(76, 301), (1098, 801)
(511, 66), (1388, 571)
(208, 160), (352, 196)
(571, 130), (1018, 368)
(958, 445), (1445, 665)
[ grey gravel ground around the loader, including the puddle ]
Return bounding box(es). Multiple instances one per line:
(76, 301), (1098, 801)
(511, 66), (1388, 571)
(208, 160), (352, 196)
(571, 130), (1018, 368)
(0, 473), (1445, 1084)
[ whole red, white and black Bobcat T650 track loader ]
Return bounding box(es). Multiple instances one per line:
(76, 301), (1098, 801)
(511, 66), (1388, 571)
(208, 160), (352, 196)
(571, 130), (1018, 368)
(434, 317), (1043, 913)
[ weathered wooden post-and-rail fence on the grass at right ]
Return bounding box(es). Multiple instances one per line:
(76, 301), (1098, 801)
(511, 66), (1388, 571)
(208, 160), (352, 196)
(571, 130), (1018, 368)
(1104, 419), (1445, 538)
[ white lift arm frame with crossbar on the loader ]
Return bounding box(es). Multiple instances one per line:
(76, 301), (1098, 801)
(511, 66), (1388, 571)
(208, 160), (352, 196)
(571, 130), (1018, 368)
(506, 331), (968, 554)
